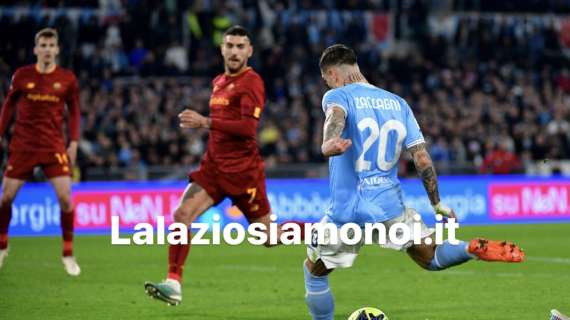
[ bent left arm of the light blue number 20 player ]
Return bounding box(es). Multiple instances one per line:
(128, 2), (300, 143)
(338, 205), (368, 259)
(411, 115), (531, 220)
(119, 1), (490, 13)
(321, 106), (352, 157)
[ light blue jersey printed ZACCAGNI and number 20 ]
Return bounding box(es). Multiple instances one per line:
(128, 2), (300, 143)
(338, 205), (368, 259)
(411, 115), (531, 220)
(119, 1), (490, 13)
(323, 83), (424, 225)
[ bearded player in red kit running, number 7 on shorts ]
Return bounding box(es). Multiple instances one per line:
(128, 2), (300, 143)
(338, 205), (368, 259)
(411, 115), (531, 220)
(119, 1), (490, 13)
(145, 26), (290, 305)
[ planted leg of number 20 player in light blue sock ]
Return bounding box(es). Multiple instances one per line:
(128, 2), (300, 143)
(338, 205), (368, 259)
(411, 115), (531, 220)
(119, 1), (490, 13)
(303, 259), (334, 320)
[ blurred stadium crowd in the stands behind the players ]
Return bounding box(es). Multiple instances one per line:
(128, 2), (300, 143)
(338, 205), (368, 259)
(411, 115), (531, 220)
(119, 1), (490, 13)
(0, 0), (570, 179)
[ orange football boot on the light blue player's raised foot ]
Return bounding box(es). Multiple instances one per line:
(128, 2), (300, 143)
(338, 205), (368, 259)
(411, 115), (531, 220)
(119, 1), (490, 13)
(468, 238), (524, 262)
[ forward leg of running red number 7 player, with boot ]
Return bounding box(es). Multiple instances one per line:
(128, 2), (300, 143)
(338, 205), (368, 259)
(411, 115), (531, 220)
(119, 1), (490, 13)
(144, 182), (214, 306)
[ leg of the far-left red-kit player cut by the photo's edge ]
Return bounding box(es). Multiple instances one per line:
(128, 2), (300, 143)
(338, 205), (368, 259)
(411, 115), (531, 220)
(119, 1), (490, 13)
(0, 176), (25, 268)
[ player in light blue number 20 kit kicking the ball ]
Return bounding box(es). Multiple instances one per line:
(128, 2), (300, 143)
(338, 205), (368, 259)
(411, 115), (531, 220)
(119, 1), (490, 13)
(304, 44), (524, 320)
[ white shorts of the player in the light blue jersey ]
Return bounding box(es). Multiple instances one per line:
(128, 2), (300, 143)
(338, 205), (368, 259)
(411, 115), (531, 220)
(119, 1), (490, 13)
(307, 208), (434, 269)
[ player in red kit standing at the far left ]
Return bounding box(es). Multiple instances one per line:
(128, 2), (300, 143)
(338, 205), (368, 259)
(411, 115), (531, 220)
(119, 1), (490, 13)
(0, 28), (81, 276)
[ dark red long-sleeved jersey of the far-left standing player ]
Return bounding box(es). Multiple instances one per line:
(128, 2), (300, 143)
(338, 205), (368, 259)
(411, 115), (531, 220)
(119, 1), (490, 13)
(0, 65), (81, 152)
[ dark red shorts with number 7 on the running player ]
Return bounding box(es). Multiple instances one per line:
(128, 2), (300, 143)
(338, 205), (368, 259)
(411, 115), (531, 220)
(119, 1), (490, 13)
(189, 163), (271, 221)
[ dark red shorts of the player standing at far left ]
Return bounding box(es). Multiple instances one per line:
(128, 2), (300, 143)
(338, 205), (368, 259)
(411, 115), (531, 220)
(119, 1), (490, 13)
(4, 151), (71, 180)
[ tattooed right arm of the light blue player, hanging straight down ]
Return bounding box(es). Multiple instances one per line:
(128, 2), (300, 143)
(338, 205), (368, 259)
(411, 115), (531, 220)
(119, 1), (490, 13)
(409, 143), (455, 218)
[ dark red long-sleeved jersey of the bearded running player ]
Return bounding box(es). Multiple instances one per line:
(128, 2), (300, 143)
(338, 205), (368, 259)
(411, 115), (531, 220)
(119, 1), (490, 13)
(203, 67), (265, 173)
